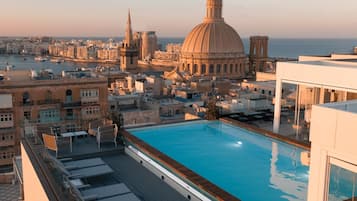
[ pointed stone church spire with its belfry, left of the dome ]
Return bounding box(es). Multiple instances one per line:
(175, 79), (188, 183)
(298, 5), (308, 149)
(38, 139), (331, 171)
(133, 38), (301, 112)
(120, 12), (139, 71)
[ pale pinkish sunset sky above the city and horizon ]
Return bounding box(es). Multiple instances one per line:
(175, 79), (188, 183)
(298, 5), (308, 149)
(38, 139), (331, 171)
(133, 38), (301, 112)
(0, 0), (357, 38)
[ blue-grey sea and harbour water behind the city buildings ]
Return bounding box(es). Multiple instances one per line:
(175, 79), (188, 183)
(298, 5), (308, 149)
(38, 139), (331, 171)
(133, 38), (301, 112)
(0, 37), (357, 73)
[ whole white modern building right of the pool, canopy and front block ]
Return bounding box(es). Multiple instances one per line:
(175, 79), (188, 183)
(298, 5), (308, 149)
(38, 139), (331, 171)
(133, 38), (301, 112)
(274, 55), (357, 201)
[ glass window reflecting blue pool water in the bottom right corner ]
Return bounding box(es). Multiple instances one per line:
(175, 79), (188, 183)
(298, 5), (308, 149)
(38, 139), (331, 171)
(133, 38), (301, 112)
(328, 165), (357, 201)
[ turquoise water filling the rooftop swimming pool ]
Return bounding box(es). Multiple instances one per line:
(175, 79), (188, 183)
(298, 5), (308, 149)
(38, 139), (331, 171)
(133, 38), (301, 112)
(129, 121), (308, 201)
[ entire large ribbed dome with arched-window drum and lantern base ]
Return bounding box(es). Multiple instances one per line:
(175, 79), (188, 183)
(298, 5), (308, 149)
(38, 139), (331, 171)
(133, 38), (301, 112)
(179, 0), (248, 78)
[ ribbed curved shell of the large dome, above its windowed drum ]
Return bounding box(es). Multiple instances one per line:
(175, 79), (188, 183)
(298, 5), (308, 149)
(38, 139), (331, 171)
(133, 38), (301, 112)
(181, 21), (244, 56)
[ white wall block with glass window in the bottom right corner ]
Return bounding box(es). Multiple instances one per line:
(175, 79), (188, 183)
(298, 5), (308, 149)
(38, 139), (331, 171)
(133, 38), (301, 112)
(308, 101), (357, 201)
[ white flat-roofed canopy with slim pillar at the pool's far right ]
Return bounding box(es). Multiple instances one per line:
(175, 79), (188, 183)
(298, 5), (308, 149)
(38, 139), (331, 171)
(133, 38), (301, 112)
(274, 60), (357, 133)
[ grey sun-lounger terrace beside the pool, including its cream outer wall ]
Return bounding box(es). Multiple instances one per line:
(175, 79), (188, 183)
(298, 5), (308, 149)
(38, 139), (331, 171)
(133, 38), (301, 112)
(21, 132), (185, 201)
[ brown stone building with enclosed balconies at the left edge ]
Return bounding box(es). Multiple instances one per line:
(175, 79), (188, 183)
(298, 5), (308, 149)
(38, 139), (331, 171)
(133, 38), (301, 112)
(0, 70), (108, 167)
